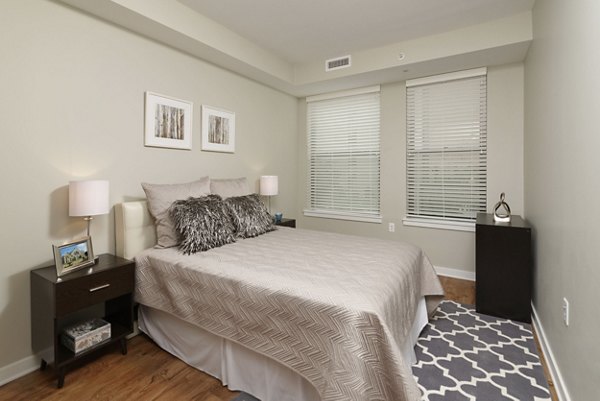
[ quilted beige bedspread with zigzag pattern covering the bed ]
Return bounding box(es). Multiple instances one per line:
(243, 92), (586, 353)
(136, 228), (443, 401)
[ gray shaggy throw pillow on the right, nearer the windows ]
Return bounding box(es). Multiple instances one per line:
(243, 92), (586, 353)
(223, 194), (275, 238)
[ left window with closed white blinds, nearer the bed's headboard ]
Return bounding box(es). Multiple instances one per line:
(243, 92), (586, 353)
(304, 86), (381, 222)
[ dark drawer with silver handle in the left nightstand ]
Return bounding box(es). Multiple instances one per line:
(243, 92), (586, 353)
(56, 264), (135, 316)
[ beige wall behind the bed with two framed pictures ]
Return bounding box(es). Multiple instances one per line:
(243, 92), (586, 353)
(0, 0), (297, 368)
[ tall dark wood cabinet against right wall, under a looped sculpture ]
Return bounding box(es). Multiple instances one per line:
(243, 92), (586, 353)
(475, 213), (532, 323)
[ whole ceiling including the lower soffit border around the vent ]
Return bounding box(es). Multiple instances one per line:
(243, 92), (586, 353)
(58, 0), (534, 97)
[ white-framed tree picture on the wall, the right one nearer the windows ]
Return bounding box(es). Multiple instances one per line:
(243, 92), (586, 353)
(202, 105), (235, 153)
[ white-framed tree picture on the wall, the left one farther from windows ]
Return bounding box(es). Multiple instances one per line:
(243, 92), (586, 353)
(144, 92), (194, 150)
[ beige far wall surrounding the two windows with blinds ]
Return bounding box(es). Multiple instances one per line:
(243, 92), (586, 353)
(297, 63), (523, 272)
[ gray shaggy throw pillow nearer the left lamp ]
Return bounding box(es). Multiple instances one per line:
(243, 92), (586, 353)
(169, 195), (235, 255)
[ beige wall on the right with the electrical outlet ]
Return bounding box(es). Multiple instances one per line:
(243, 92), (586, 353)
(525, 0), (600, 400)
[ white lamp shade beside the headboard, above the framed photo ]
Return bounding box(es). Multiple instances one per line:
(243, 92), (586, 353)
(69, 180), (109, 216)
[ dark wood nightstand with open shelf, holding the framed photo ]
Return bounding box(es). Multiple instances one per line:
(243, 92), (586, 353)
(30, 254), (135, 388)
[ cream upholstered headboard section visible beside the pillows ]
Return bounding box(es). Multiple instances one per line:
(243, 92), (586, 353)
(115, 201), (156, 259)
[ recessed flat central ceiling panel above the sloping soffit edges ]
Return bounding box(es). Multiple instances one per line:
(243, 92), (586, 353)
(178, 0), (534, 63)
